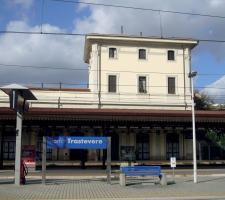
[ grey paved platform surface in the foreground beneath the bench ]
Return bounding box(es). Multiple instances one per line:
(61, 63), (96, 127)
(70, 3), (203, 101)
(0, 170), (225, 200)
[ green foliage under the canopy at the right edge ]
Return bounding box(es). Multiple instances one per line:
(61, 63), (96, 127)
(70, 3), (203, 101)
(206, 129), (225, 149)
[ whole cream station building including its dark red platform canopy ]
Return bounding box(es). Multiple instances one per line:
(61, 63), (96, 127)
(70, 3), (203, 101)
(0, 34), (225, 165)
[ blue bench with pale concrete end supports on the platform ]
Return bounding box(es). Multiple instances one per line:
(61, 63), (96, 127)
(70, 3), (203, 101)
(120, 166), (167, 186)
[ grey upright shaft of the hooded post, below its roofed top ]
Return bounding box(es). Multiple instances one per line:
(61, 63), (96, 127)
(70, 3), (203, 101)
(15, 112), (23, 185)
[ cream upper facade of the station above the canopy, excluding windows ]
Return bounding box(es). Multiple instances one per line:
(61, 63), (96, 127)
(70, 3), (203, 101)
(0, 34), (198, 110)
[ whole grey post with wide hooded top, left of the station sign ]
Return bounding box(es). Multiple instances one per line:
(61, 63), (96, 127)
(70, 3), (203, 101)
(0, 84), (37, 185)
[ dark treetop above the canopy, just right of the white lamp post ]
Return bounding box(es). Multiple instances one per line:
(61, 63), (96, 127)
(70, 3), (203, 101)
(194, 91), (214, 110)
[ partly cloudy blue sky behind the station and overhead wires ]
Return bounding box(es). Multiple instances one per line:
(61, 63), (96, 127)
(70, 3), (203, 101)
(0, 0), (225, 103)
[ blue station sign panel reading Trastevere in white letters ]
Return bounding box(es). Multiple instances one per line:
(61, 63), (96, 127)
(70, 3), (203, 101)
(47, 136), (107, 149)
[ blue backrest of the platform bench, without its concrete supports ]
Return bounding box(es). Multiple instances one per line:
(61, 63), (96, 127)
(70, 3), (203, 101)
(120, 166), (161, 174)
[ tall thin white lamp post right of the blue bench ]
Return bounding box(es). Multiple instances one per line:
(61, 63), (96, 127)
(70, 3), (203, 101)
(188, 71), (197, 183)
